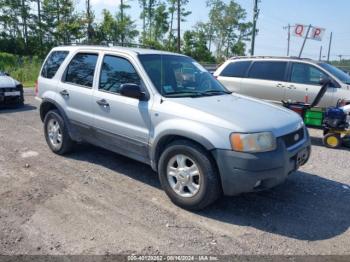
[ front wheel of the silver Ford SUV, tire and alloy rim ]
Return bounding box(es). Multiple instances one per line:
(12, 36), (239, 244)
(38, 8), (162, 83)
(158, 140), (221, 210)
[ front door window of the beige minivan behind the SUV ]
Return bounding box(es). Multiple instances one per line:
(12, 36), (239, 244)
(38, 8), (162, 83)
(290, 63), (328, 85)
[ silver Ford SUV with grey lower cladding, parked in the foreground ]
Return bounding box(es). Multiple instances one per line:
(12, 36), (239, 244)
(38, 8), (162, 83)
(37, 46), (310, 209)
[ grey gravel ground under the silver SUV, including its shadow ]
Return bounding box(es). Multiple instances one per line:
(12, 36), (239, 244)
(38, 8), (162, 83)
(0, 90), (350, 255)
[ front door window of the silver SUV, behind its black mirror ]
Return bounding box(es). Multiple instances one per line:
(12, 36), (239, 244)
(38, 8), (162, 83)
(99, 55), (141, 93)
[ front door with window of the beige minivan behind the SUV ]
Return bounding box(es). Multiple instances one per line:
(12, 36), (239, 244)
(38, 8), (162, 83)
(284, 62), (335, 107)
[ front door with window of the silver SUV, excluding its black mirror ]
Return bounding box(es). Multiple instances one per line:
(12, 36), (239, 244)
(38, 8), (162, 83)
(92, 54), (150, 162)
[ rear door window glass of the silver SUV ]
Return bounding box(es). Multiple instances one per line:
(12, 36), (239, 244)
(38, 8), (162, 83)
(64, 53), (98, 87)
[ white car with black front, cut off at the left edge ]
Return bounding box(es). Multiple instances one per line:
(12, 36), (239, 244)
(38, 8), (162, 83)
(0, 71), (24, 107)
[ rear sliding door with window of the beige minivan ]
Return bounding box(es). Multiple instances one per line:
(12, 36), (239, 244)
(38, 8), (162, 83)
(240, 61), (288, 102)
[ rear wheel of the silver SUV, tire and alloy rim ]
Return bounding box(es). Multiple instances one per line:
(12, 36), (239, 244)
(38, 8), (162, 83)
(44, 110), (74, 155)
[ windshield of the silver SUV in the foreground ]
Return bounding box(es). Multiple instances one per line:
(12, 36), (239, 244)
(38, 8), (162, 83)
(139, 54), (231, 97)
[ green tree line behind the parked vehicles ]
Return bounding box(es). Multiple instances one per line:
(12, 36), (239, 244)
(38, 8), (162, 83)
(0, 0), (252, 62)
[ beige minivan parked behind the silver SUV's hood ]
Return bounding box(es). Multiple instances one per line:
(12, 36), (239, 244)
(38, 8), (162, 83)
(214, 57), (350, 107)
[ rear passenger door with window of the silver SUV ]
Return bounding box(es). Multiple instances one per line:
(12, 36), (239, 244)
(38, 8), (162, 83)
(57, 52), (98, 130)
